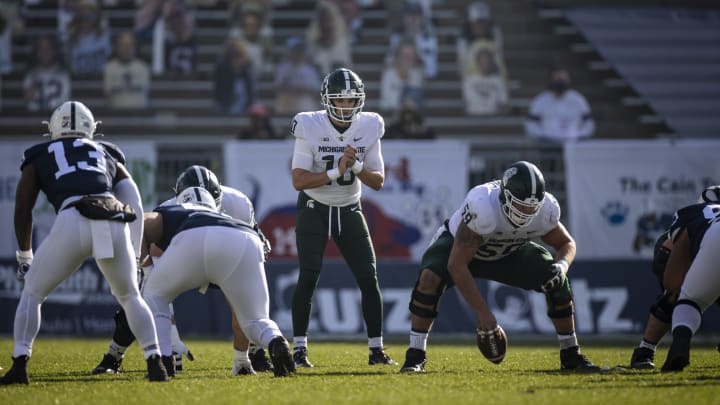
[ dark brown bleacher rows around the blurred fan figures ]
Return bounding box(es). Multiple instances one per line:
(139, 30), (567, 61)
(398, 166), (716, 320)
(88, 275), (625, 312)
(0, 0), (688, 141)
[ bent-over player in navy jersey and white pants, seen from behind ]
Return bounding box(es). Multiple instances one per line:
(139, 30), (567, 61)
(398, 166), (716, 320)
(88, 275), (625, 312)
(142, 187), (295, 377)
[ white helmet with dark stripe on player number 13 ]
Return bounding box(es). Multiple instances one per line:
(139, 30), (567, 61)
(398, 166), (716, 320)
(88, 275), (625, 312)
(42, 101), (101, 139)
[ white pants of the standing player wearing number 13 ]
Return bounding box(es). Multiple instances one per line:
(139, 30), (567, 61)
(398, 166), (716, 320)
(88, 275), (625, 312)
(13, 208), (159, 358)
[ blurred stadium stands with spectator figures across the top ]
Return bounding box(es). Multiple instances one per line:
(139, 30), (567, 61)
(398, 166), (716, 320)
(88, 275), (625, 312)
(0, 0), (720, 142)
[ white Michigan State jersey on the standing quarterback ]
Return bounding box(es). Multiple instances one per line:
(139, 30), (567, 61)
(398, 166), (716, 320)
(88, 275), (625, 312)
(291, 110), (385, 207)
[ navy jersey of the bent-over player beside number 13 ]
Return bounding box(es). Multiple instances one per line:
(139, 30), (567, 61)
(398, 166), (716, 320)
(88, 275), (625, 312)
(155, 204), (255, 250)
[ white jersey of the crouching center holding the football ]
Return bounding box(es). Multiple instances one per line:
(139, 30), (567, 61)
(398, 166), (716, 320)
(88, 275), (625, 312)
(448, 181), (560, 260)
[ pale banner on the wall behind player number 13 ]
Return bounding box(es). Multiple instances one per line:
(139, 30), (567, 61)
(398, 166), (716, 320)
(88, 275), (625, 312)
(0, 138), (157, 260)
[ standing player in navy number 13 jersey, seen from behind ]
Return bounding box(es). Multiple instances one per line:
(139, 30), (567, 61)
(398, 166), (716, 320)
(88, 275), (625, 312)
(0, 101), (168, 384)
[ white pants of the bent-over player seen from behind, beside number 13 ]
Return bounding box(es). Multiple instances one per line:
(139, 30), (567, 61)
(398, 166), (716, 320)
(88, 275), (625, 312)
(143, 226), (282, 356)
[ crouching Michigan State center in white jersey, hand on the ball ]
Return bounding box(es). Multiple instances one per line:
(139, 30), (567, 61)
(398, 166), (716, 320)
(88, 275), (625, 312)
(400, 161), (599, 373)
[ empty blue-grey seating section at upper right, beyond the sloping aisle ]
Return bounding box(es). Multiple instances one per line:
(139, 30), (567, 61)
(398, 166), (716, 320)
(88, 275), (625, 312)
(565, 7), (720, 137)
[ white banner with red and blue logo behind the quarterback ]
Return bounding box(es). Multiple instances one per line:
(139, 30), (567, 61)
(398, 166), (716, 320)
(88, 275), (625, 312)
(224, 140), (469, 261)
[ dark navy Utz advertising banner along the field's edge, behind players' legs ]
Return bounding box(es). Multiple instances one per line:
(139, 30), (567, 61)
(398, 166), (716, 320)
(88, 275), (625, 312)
(0, 260), (720, 341)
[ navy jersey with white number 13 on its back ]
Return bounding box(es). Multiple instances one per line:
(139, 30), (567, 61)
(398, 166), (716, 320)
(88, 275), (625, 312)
(20, 138), (125, 212)
